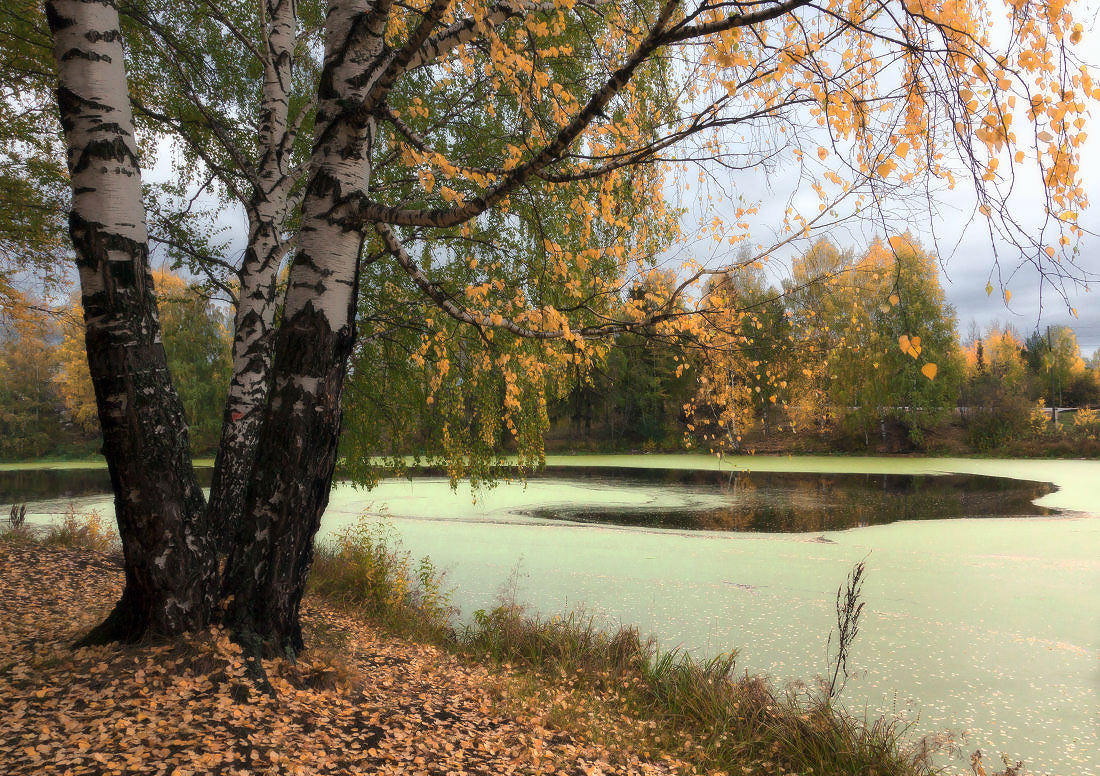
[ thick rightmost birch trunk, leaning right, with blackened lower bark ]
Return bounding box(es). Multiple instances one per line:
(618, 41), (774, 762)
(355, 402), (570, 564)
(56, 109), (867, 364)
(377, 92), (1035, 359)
(222, 0), (385, 653)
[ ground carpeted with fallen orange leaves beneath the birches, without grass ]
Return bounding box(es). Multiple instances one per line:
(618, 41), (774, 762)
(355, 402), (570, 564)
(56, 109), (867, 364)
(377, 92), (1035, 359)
(0, 540), (677, 776)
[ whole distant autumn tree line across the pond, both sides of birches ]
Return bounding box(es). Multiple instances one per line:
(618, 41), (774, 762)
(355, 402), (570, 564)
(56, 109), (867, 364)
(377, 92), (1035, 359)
(0, 245), (1100, 460)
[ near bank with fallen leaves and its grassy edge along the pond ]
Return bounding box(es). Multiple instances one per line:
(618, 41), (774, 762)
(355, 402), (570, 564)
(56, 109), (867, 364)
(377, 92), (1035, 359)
(0, 536), (946, 776)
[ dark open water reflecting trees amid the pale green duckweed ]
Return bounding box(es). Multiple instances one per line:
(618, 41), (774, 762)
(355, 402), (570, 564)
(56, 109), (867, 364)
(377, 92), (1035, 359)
(0, 467), (1055, 533)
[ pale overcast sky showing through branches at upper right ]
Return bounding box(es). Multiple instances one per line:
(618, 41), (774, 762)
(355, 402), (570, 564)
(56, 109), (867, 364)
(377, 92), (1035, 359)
(655, 5), (1100, 357)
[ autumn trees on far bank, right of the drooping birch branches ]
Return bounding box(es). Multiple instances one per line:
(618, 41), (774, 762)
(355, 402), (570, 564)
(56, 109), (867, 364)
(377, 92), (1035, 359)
(549, 236), (1100, 451)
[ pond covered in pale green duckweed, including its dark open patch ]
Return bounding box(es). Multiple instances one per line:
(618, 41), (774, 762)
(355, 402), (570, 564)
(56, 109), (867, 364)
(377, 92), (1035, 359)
(0, 456), (1100, 776)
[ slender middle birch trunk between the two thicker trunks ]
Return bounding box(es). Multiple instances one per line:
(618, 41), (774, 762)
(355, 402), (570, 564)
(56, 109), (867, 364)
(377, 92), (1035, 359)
(208, 0), (298, 536)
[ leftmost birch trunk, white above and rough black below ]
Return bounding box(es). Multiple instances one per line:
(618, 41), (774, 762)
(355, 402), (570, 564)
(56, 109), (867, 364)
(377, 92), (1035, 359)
(45, 0), (217, 642)
